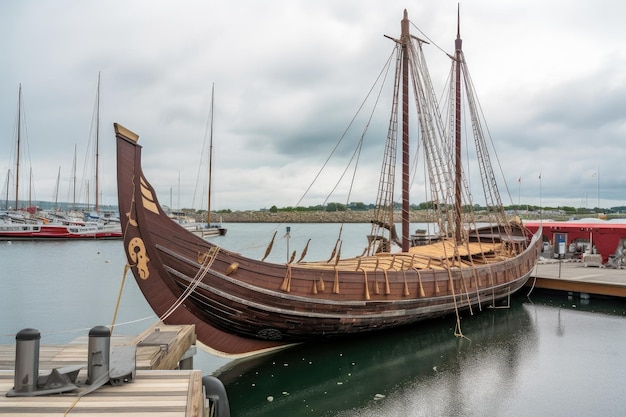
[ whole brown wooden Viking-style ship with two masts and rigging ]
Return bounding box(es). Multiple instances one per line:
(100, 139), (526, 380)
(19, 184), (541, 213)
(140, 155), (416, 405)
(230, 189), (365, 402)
(114, 10), (541, 357)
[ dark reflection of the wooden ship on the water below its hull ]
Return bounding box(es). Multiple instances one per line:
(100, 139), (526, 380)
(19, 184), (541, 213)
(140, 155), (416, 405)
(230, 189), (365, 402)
(216, 300), (536, 416)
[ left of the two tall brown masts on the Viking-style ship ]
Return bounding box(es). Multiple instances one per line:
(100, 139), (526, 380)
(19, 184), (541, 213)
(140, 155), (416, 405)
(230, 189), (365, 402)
(400, 9), (411, 252)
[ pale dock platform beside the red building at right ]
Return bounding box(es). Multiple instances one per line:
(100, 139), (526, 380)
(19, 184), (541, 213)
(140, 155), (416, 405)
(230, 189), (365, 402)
(526, 259), (626, 297)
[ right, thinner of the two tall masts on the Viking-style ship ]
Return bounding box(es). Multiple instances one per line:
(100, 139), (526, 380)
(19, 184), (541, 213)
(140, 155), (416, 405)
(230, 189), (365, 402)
(454, 6), (463, 242)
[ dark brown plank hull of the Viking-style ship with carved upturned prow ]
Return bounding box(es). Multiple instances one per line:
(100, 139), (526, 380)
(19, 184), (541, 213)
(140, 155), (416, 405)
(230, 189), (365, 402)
(116, 123), (541, 355)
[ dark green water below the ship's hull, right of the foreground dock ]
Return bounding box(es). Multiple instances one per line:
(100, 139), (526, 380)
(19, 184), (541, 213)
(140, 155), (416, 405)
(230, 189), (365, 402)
(219, 293), (626, 417)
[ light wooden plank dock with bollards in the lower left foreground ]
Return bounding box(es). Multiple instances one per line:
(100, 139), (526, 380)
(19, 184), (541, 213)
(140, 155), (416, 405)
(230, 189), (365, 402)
(0, 323), (223, 417)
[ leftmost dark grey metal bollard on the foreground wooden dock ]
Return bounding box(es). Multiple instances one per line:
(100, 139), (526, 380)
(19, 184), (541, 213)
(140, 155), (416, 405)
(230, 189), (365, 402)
(12, 329), (41, 395)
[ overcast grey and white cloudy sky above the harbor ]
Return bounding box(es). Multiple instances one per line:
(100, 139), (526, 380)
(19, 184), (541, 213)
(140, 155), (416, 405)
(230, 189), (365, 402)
(0, 0), (626, 210)
